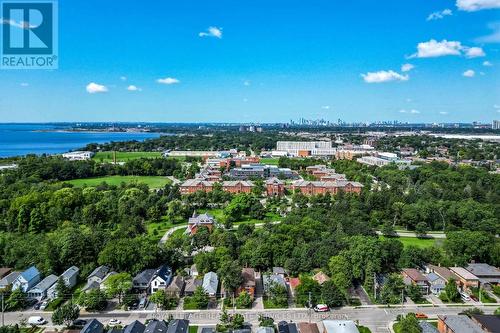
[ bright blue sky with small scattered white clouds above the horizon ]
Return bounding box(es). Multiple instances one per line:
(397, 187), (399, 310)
(0, 0), (500, 122)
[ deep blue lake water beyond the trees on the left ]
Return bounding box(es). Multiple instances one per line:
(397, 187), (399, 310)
(0, 124), (160, 157)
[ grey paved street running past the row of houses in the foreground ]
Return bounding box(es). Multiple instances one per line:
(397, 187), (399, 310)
(5, 305), (498, 333)
